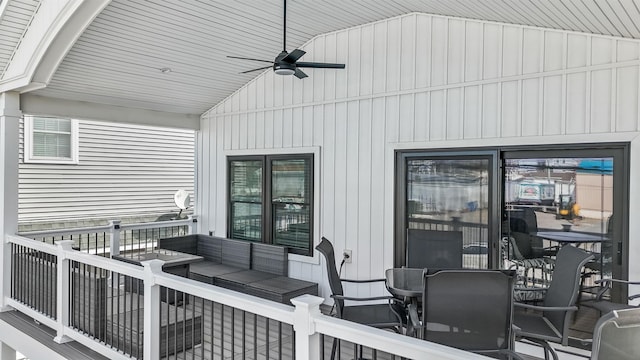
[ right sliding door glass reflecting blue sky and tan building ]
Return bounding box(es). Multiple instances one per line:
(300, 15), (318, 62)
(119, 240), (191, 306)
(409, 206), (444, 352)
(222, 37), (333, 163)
(502, 156), (617, 292)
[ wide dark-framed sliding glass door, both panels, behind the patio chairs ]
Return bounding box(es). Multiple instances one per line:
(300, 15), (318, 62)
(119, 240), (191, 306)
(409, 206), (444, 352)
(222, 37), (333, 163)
(394, 143), (629, 301)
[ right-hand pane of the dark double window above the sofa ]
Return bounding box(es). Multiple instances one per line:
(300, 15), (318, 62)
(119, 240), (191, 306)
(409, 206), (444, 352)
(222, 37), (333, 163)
(271, 159), (312, 252)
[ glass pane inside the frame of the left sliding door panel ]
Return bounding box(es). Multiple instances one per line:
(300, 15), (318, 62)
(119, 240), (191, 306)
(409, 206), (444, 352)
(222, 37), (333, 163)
(406, 158), (490, 268)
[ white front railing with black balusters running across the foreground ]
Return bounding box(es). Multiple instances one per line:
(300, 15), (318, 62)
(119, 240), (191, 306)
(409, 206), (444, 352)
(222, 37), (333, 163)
(3, 235), (485, 360)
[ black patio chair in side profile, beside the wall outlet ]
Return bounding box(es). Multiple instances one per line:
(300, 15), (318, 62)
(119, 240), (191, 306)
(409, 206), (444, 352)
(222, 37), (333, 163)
(316, 237), (406, 359)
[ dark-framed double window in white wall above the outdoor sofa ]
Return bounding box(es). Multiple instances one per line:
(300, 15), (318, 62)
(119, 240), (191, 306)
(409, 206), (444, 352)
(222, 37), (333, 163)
(228, 154), (313, 256)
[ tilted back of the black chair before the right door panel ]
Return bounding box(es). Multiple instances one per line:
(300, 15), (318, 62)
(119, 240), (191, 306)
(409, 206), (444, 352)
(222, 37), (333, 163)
(543, 245), (594, 334)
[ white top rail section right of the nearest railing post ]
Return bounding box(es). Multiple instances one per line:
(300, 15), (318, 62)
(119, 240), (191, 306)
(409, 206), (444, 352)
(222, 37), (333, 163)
(314, 314), (488, 360)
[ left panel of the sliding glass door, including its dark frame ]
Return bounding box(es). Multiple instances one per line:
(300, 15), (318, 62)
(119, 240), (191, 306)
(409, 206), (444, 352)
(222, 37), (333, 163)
(395, 153), (496, 268)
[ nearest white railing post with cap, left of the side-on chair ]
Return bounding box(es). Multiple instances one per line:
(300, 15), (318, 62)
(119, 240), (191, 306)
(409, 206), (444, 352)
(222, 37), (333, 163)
(291, 295), (324, 360)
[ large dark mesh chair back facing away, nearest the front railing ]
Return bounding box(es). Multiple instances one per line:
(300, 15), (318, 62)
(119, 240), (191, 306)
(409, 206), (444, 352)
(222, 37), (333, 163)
(422, 269), (516, 352)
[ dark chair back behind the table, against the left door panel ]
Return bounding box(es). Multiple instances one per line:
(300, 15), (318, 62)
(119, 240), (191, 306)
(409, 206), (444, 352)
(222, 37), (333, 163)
(406, 229), (462, 269)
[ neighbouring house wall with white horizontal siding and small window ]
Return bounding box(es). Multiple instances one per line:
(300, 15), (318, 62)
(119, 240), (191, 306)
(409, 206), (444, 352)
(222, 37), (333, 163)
(18, 115), (195, 231)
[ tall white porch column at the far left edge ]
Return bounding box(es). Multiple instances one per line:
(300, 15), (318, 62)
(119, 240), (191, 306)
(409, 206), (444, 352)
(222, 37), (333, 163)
(0, 92), (22, 311)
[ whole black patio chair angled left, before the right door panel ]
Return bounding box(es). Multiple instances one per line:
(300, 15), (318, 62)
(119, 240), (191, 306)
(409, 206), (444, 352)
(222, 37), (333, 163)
(513, 245), (594, 360)
